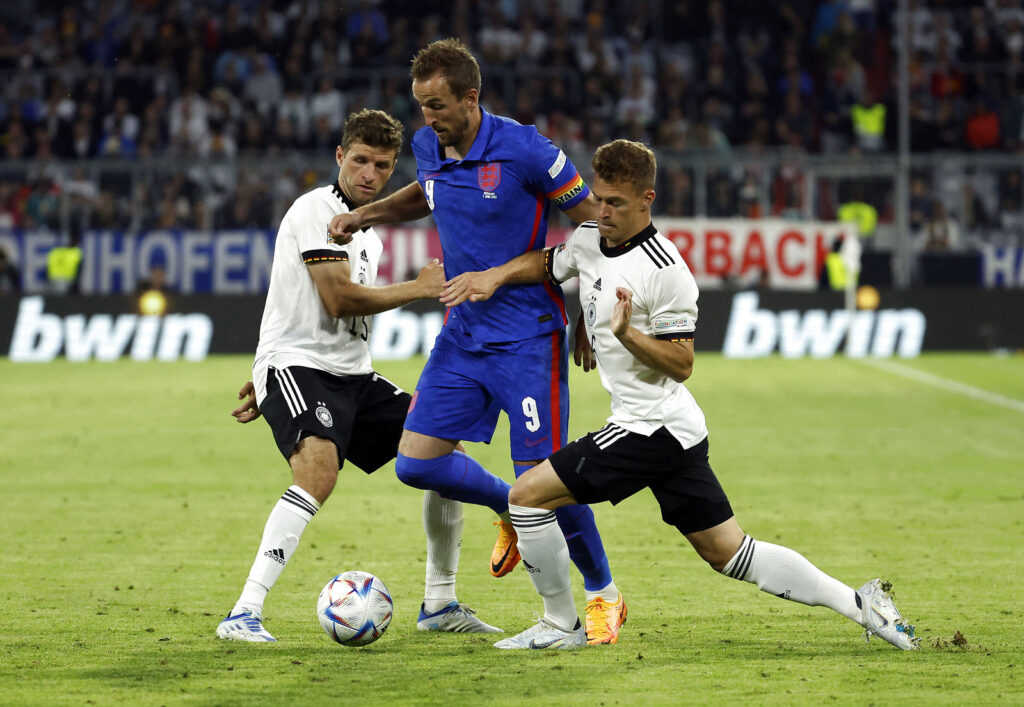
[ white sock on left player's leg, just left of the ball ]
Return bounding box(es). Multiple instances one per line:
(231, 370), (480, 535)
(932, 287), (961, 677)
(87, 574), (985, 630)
(231, 485), (319, 615)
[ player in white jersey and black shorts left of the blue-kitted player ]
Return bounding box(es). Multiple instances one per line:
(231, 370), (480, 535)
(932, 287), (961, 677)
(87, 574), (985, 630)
(217, 110), (500, 642)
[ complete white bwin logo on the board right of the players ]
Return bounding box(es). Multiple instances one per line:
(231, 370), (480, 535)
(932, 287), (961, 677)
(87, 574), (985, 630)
(722, 292), (926, 359)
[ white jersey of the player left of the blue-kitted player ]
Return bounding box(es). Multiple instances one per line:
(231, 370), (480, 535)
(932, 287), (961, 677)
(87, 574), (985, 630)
(253, 182), (384, 403)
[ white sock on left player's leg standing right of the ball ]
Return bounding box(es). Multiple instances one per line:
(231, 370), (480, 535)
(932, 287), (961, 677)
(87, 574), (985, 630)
(423, 491), (463, 614)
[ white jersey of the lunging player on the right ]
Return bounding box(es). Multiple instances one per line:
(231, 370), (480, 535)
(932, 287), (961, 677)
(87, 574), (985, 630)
(547, 221), (708, 442)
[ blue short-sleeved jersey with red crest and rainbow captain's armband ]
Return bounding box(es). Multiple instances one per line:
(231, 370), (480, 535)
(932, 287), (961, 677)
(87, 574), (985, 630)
(413, 109), (590, 350)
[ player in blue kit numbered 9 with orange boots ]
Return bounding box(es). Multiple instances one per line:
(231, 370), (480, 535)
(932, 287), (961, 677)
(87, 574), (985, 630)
(330, 39), (627, 643)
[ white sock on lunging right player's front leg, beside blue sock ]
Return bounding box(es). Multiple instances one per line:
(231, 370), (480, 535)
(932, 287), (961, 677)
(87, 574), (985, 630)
(509, 503), (579, 630)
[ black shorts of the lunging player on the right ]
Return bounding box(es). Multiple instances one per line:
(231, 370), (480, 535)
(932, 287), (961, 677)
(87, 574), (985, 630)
(549, 423), (732, 535)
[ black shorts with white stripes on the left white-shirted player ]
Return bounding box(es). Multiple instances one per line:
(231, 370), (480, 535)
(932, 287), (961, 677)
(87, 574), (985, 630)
(260, 366), (412, 473)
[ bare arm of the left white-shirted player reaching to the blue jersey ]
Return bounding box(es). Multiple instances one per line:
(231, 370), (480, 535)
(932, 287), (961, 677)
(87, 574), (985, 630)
(309, 258), (444, 319)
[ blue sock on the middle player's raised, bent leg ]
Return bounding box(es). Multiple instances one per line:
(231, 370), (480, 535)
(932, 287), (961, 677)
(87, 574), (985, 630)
(394, 452), (511, 513)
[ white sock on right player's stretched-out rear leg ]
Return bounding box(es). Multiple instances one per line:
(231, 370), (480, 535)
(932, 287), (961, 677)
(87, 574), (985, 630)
(722, 535), (862, 624)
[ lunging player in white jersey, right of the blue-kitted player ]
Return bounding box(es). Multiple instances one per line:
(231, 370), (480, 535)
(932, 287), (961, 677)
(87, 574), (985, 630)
(441, 140), (918, 650)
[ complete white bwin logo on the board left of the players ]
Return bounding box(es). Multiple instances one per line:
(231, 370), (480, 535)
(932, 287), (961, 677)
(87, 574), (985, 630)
(8, 297), (213, 362)
